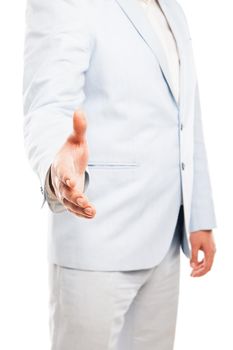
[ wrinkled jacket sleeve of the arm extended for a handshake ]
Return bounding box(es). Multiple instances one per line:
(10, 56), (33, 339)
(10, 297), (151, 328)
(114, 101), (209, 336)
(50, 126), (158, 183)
(23, 0), (94, 209)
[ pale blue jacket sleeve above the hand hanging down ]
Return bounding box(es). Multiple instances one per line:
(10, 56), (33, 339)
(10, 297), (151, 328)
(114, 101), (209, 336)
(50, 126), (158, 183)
(189, 84), (217, 232)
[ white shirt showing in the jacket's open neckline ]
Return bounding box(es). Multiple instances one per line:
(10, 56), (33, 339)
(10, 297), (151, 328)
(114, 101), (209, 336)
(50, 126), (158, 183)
(137, 0), (180, 101)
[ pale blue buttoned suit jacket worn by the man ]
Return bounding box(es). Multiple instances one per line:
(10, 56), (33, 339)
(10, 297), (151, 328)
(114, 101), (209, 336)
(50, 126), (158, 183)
(24, 0), (216, 270)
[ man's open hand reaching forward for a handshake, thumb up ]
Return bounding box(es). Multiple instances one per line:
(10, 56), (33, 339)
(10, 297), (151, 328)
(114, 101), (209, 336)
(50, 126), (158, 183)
(51, 110), (96, 219)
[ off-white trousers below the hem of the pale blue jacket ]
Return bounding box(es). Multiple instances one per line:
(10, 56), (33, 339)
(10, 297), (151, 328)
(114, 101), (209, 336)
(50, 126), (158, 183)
(49, 206), (182, 350)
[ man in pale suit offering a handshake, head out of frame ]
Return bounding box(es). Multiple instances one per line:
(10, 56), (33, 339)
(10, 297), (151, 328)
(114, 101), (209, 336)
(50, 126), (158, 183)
(24, 0), (216, 350)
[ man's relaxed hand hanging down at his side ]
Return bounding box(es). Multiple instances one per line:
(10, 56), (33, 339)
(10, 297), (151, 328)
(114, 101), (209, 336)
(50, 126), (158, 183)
(190, 230), (216, 277)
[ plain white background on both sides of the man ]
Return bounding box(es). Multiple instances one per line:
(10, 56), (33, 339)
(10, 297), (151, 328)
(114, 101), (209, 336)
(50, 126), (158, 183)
(0, 0), (230, 350)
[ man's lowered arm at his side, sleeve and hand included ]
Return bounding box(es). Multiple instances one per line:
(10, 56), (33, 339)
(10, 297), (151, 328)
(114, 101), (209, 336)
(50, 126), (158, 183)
(189, 85), (216, 277)
